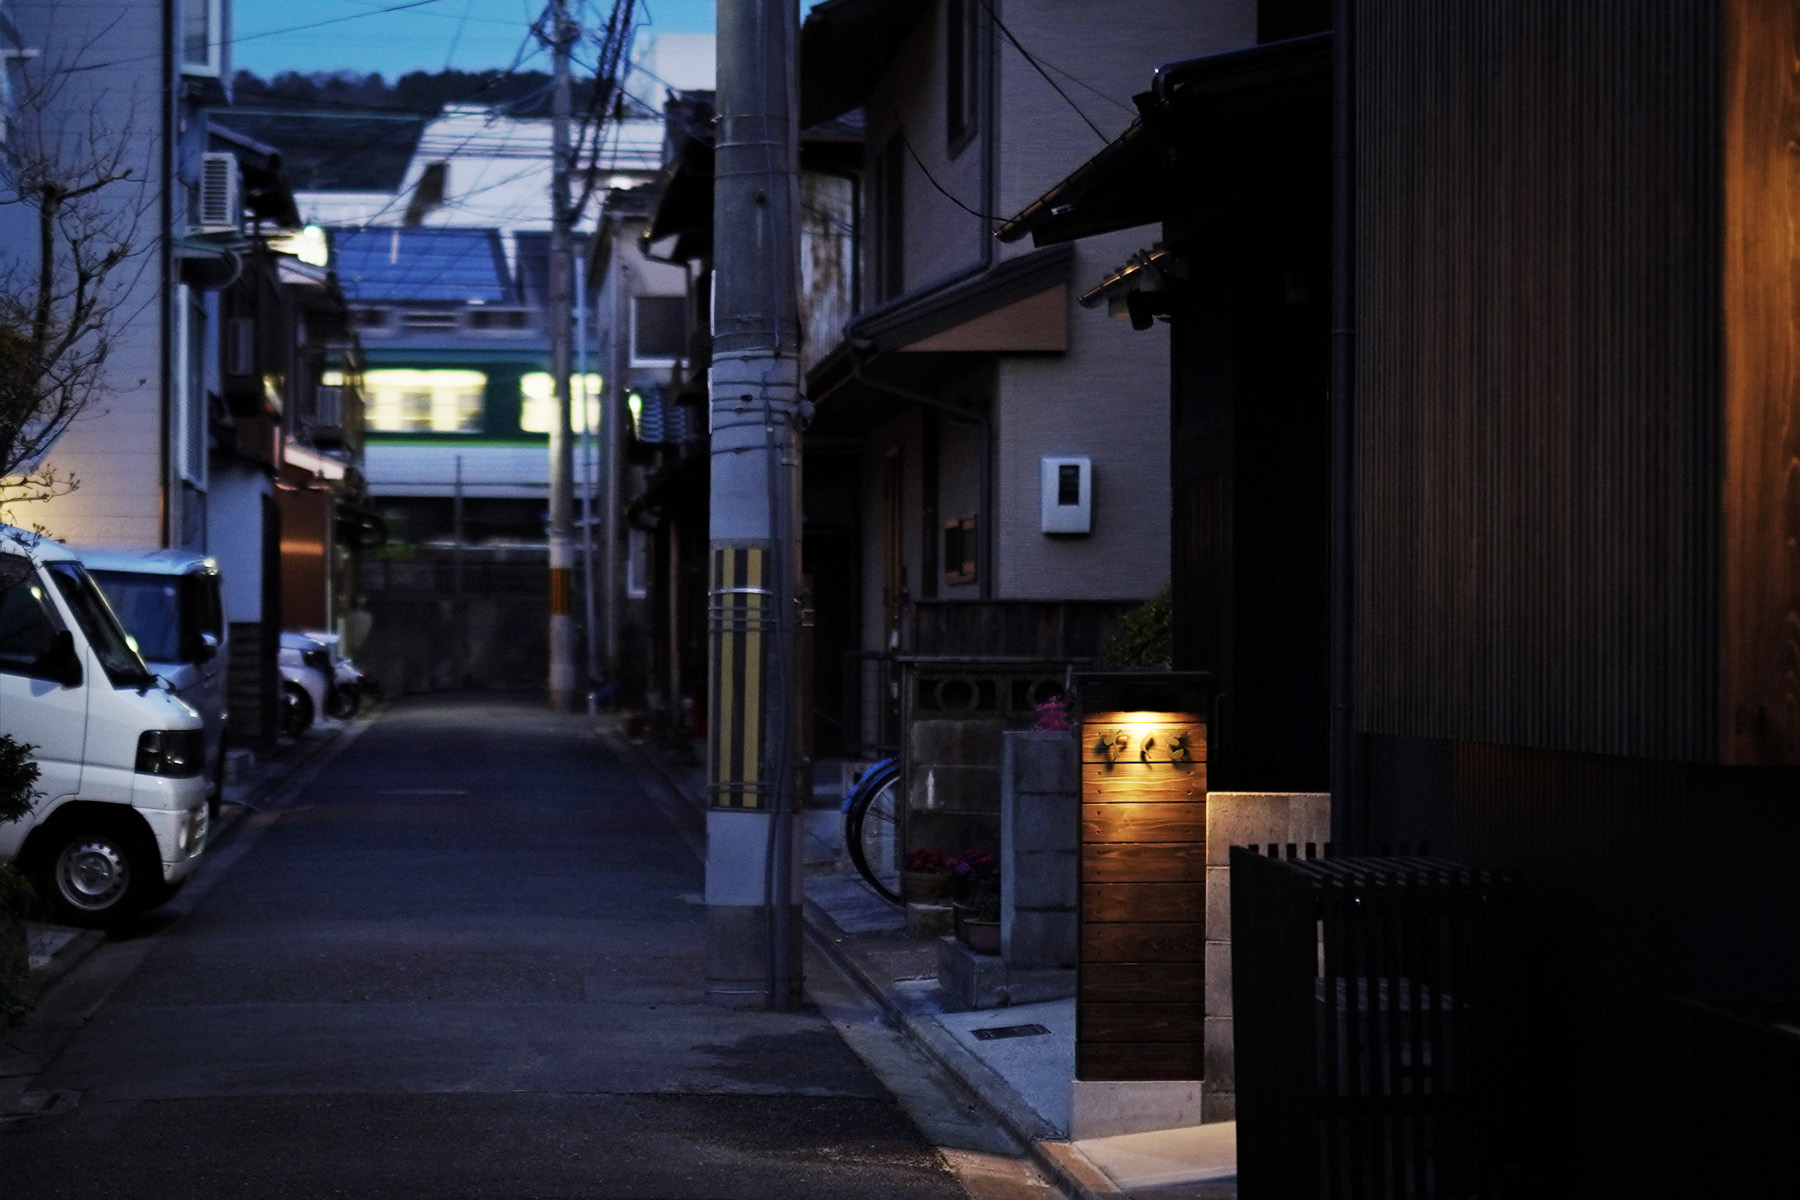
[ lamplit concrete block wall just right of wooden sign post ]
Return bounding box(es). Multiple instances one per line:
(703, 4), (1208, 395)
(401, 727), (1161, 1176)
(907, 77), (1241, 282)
(1201, 792), (1332, 1123)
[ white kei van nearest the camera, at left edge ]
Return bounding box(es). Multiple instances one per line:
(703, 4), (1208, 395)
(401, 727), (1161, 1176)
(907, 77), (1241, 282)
(0, 525), (209, 927)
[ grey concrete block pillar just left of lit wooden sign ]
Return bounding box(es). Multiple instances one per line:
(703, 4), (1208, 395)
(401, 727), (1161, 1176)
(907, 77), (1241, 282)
(1001, 732), (1082, 968)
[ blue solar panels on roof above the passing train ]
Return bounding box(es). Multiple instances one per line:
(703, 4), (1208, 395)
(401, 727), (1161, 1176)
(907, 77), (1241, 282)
(331, 228), (511, 304)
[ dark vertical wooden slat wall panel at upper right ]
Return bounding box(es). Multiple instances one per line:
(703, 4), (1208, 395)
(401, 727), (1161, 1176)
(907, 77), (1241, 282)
(1354, 0), (1720, 761)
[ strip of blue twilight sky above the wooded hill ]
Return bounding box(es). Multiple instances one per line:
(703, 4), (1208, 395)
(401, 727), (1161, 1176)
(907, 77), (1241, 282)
(229, 0), (720, 81)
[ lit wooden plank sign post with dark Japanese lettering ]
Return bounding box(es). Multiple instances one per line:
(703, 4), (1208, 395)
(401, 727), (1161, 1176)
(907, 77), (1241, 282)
(1075, 712), (1206, 1079)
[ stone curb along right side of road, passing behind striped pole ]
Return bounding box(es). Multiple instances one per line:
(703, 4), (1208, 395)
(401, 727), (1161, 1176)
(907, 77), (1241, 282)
(596, 725), (1127, 1200)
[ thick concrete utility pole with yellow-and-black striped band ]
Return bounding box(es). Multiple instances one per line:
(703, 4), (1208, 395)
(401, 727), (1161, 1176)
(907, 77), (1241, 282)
(706, 0), (808, 1009)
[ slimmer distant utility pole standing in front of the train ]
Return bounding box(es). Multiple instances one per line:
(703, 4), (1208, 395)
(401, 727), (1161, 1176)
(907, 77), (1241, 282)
(538, 0), (580, 712)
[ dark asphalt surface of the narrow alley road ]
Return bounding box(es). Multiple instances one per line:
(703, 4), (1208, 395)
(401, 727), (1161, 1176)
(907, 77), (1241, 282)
(0, 698), (1000, 1200)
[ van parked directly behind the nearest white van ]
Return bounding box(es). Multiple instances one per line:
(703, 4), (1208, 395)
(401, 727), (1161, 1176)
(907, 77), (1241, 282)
(70, 547), (230, 820)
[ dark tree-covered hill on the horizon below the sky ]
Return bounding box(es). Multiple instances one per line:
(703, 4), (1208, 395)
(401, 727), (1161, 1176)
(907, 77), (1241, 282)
(232, 70), (615, 117)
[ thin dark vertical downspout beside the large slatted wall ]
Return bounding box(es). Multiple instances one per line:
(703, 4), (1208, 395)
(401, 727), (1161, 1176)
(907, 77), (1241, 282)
(1330, 0), (1368, 853)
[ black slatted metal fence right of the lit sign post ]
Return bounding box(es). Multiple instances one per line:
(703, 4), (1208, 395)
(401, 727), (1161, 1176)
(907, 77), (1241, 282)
(1231, 846), (1516, 1200)
